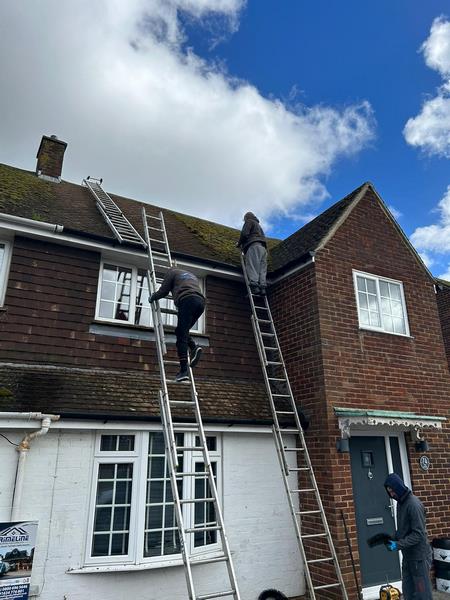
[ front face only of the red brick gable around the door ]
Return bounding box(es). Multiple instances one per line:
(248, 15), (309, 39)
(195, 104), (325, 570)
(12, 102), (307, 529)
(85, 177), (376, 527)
(316, 192), (450, 596)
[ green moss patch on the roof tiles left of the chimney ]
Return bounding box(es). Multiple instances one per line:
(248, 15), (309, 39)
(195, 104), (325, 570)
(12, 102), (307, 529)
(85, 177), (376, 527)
(0, 164), (55, 221)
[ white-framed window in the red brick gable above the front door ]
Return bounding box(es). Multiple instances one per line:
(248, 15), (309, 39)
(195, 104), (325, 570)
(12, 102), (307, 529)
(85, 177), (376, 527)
(353, 271), (409, 336)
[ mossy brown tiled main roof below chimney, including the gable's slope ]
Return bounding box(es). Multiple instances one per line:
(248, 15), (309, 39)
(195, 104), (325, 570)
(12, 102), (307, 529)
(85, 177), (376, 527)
(0, 164), (362, 272)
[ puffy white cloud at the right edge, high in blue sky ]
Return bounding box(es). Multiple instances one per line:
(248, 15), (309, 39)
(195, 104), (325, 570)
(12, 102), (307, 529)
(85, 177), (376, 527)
(403, 17), (450, 158)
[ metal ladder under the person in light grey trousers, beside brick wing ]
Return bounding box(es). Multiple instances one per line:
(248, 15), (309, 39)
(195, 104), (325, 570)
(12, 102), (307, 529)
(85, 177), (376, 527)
(241, 255), (348, 600)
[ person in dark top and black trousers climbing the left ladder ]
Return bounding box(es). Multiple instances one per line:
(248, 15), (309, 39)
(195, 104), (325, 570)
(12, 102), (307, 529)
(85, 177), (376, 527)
(149, 267), (205, 381)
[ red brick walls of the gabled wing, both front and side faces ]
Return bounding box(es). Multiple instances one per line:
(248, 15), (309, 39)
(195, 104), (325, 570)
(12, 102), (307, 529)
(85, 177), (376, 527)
(271, 186), (450, 598)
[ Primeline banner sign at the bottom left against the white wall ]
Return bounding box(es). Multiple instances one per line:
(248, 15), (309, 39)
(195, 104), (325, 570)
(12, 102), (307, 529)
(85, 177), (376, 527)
(0, 521), (38, 600)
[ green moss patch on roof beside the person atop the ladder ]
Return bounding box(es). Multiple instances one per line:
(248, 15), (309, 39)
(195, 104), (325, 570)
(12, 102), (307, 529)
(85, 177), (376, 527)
(171, 211), (280, 265)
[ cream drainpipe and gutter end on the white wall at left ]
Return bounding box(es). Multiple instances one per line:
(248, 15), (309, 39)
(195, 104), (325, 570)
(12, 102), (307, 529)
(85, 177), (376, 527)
(0, 412), (59, 521)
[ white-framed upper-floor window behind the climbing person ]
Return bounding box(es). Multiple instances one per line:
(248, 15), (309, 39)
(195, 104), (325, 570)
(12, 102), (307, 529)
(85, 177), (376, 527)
(95, 258), (205, 335)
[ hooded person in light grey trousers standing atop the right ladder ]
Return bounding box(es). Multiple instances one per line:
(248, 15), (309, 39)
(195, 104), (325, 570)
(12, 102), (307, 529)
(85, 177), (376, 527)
(236, 212), (267, 296)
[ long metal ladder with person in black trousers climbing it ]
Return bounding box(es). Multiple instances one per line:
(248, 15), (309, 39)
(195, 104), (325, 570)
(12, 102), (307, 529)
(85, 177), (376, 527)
(142, 207), (241, 600)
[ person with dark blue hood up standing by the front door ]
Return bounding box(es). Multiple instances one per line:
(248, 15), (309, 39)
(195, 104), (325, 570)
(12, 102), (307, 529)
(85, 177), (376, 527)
(384, 473), (432, 600)
